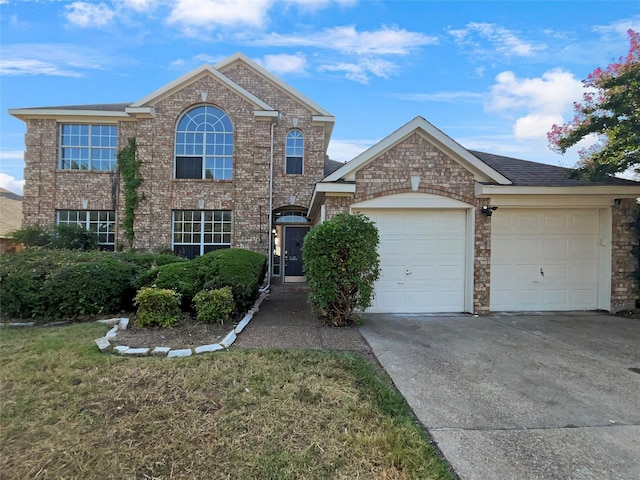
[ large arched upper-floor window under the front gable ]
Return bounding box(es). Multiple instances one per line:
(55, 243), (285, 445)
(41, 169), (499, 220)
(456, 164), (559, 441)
(175, 105), (233, 180)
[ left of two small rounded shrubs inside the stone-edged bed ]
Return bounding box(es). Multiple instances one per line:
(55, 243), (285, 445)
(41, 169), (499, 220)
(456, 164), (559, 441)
(134, 287), (180, 327)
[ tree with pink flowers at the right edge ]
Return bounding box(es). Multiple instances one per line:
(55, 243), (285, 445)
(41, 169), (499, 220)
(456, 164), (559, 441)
(547, 30), (640, 180)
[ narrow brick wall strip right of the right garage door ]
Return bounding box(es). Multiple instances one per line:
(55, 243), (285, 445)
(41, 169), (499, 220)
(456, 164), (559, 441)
(611, 198), (638, 311)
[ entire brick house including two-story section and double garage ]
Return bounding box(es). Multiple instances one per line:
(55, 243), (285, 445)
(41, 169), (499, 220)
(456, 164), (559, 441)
(10, 54), (640, 313)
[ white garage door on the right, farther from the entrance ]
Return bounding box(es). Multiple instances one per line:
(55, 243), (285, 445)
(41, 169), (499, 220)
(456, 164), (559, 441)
(491, 208), (600, 311)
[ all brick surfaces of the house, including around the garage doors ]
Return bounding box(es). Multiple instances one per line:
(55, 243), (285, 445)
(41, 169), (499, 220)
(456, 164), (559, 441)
(11, 58), (638, 314)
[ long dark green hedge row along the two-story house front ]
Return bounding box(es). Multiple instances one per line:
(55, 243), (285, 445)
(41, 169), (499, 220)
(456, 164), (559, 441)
(0, 249), (266, 320)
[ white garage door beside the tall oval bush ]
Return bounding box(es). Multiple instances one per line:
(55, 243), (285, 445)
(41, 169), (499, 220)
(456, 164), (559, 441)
(362, 209), (466, 313)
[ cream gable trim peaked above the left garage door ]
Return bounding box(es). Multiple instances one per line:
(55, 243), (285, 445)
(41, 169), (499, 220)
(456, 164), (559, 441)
(322, 117), (511, 185)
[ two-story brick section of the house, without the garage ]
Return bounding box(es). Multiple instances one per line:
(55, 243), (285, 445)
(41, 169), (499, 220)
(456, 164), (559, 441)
(10, 54), (335, 281)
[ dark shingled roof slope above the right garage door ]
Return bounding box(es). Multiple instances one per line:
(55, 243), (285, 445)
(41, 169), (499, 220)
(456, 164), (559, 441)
(469, 150), (640, 187)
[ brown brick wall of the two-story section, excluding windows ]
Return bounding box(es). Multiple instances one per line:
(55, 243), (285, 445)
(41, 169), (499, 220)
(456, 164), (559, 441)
(23, 64), (326, 254)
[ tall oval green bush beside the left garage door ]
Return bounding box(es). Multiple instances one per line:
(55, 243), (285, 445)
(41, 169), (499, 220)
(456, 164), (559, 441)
(302, 214), (380, 327)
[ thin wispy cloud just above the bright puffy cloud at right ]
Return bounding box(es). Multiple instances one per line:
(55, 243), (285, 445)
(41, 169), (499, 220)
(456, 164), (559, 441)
(449, 22), (546, 57)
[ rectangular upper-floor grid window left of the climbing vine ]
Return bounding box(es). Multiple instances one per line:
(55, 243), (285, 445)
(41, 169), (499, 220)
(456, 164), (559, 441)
(58, 123), (118, 171)
